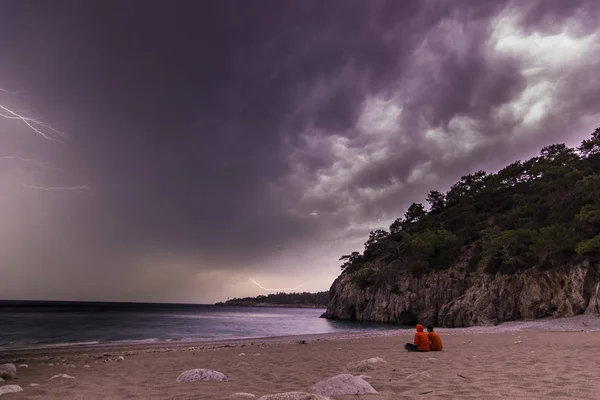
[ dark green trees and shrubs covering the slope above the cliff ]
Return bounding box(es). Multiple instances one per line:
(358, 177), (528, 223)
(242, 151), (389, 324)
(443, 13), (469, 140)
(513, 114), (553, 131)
(340, 128), (600, 282)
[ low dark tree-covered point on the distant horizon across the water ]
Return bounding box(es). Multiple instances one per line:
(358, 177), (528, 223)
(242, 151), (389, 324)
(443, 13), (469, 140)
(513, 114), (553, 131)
(215, 292), (329, 308)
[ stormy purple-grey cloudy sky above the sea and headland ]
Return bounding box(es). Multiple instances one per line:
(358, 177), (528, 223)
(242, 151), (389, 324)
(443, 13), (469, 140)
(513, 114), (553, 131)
(0, 0), (600, 302)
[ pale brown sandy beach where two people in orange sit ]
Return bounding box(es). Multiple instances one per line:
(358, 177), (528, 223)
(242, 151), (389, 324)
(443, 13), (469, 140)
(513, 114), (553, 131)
(0, 317), (600, 400)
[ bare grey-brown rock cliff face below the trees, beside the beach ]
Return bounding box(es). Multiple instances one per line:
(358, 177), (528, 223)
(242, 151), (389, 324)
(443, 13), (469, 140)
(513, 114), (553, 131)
(323, 253), (600, 327)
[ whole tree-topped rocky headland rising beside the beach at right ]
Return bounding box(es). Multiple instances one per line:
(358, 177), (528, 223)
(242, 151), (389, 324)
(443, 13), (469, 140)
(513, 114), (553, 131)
(323, 129), (600, 327)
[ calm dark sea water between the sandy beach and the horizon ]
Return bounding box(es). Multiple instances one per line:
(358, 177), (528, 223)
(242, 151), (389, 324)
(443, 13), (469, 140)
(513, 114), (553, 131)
(0, 301), (398, 349)
